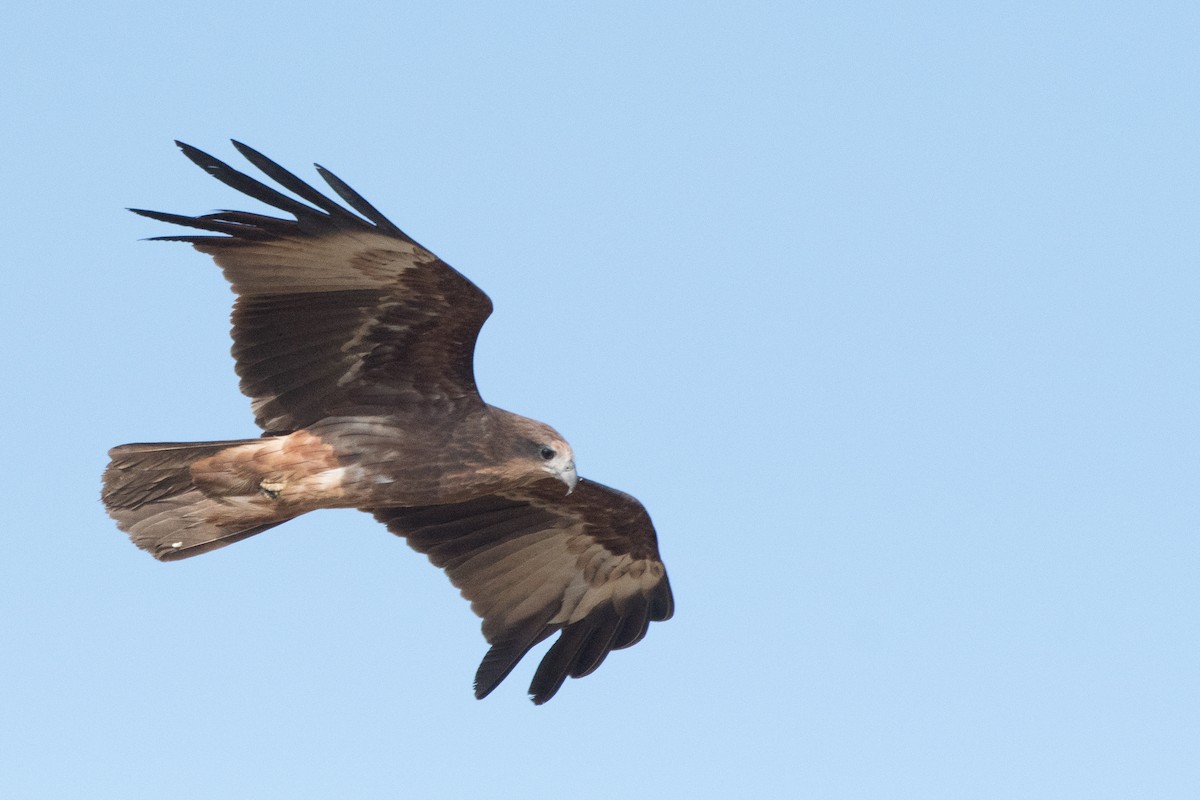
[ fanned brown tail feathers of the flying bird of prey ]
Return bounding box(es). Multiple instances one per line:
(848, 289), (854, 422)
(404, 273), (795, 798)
(101, 439), (292, 561)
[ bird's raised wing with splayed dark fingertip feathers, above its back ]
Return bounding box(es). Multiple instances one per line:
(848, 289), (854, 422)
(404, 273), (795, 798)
(132, 142), (492, 433)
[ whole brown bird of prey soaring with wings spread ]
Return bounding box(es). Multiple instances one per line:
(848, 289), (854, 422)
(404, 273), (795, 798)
(102, 142), (673, 703)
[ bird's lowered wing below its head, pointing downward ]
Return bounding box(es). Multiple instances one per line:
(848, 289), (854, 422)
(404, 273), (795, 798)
(373, 480), (674, 704)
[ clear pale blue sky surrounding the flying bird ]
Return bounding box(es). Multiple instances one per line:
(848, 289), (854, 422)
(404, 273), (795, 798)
(0, 0), (1200, 800)
